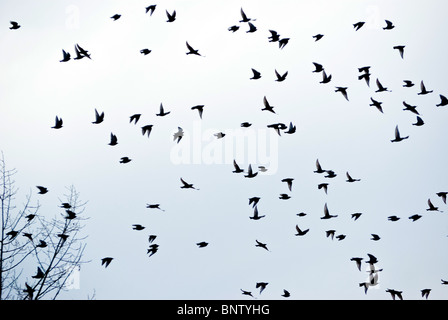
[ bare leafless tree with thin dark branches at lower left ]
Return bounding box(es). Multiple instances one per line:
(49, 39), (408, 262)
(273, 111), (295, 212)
(0, 155), (86, 300)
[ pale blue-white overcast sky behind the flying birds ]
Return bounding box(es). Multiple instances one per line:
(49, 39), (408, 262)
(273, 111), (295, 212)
(0, 0), (448, 299)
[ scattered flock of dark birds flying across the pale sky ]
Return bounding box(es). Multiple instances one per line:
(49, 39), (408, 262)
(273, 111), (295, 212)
(9, 5), (448, 300)
